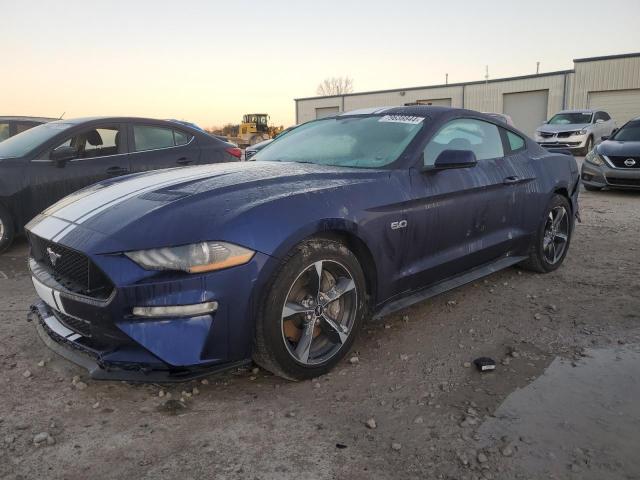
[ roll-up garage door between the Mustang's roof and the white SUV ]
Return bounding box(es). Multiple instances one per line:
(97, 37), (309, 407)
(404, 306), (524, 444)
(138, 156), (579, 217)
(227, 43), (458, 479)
(502, 90), (549, 136)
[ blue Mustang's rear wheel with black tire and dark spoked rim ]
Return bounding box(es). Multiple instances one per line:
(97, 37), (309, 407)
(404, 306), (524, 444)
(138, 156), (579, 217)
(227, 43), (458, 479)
(521, 194), (573, 273)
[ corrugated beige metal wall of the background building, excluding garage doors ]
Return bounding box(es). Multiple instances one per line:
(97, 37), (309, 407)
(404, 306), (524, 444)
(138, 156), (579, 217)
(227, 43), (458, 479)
(296, 54), (640, 123)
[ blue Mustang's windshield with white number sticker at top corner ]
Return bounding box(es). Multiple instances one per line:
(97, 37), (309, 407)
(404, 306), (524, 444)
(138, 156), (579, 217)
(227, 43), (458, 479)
(254, 115), (424, 168)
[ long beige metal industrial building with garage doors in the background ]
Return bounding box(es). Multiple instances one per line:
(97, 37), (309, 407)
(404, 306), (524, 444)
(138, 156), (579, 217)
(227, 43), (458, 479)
(295, 53), (640, 135)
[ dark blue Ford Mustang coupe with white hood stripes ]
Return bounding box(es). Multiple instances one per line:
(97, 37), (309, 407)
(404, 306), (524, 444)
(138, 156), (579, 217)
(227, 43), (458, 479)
(27, 106), (579, 381)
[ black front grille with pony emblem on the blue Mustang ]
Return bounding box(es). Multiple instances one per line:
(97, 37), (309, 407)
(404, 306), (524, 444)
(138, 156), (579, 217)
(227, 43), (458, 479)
(29, 234), (114, 300)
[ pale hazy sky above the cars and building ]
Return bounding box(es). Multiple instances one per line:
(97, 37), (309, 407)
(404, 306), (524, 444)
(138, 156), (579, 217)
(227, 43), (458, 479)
(0, 0), (640, 127)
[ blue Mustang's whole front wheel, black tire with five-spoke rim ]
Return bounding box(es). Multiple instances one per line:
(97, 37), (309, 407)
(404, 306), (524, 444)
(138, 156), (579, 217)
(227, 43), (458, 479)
(253, 239), (367, 380)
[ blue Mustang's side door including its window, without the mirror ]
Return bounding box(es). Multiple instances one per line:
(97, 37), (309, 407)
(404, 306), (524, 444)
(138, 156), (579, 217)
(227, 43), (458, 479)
(407, 118), (516, 286)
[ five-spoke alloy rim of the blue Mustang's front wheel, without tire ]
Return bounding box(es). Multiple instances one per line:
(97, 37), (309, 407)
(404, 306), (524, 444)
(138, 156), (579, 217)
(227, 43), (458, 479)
(281, 260), (358, 365)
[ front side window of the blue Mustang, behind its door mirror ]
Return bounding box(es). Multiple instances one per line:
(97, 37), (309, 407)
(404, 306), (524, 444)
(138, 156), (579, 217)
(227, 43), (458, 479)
(424, 118), (504, 166)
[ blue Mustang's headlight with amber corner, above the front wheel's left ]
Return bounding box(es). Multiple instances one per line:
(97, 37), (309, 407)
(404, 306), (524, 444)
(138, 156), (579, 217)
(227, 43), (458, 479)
(125, 242), (255, 273)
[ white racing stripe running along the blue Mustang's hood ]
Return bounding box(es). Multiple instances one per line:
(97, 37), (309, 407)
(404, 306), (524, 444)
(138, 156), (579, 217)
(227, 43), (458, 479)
(45, 165), (224, 224)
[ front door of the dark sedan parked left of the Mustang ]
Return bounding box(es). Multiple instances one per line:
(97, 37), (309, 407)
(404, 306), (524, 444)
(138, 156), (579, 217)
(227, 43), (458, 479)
(29, 123), (129, 221)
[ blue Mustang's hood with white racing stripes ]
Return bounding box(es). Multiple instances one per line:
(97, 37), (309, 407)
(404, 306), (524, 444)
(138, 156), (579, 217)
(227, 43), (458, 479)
(27, 162), (389, 253)
